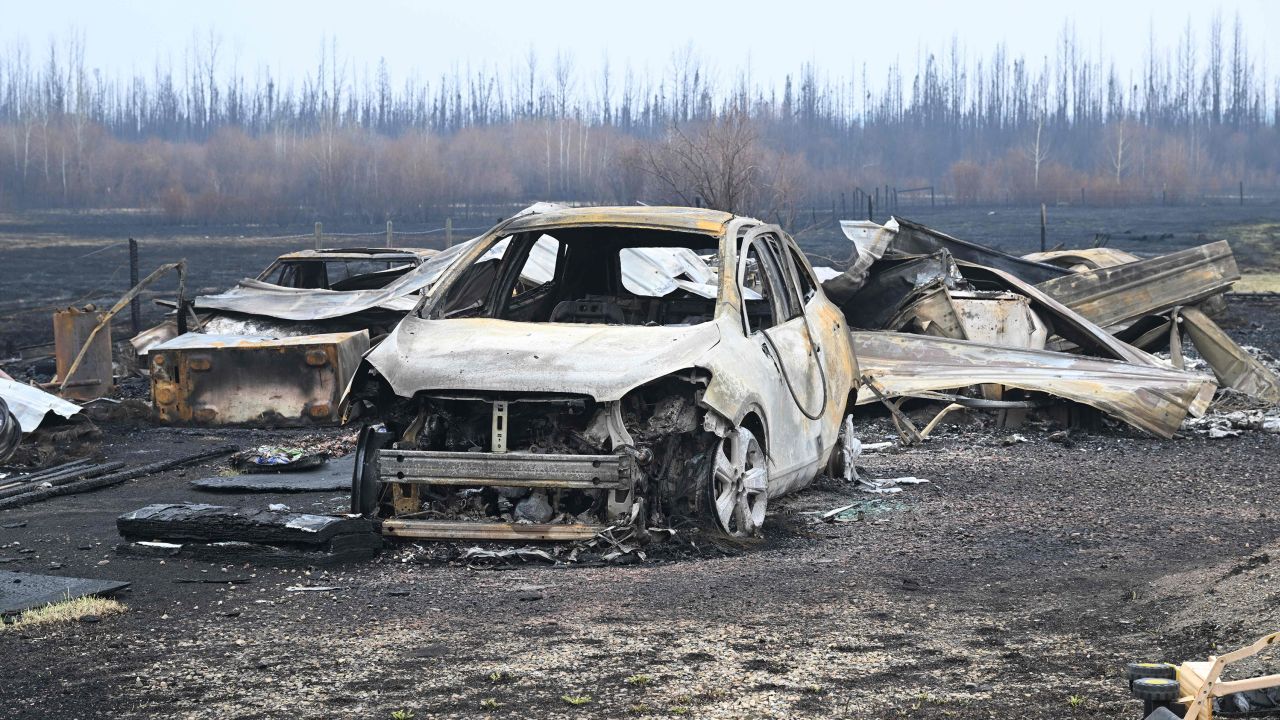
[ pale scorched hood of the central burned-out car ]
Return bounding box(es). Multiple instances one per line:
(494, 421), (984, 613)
(367, 315), (721, 402)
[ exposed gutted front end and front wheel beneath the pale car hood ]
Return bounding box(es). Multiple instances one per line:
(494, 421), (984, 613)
(353, 370), (747, 539)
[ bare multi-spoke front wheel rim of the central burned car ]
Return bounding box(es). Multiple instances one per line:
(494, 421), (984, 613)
(710, 428), (769, 537)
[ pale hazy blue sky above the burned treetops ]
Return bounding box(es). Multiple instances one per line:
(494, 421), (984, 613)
(0, 0), (1280, 90)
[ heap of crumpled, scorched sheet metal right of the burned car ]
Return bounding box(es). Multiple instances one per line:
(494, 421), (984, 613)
(823, 212), (1280, 442)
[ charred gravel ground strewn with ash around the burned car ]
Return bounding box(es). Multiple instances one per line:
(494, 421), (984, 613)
(0, 213), (1280, 719)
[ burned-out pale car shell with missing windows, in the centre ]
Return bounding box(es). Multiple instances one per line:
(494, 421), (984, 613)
(352, 208), (856, 539)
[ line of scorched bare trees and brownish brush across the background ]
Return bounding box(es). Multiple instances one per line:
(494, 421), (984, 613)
(0, 14), (1280, 223)
